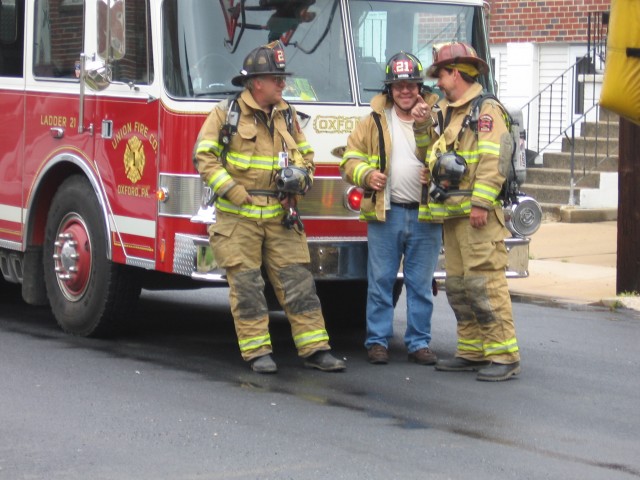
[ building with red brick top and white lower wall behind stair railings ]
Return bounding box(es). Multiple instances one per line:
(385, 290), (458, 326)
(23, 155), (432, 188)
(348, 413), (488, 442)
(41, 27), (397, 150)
(488, 0), (617, 207)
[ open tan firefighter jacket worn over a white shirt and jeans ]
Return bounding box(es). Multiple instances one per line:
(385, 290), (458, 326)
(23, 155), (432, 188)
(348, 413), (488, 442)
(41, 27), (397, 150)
(340, 93), (437, 222)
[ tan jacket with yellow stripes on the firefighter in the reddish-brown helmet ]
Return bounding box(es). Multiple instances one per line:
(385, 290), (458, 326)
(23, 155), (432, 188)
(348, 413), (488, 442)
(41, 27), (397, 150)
(414, 83), (513, 218)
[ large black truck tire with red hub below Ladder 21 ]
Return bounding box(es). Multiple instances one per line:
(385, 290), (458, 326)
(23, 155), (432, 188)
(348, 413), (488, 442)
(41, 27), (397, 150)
(43, 175), (140, 337)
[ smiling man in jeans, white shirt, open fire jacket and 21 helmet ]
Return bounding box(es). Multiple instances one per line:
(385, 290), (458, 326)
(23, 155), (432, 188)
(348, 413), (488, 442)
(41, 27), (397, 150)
(340, 52), (442, 365)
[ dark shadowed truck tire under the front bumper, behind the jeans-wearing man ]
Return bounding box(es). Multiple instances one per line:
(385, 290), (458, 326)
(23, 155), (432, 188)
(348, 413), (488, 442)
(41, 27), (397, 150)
(316, 280), (403, 327)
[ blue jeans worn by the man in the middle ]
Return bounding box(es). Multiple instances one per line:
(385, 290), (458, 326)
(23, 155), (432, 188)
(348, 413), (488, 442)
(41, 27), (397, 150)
(365, 205), (442, 353)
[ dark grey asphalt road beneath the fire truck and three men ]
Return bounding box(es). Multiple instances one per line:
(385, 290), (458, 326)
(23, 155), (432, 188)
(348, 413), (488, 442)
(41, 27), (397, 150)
(0, 283), (640, 480)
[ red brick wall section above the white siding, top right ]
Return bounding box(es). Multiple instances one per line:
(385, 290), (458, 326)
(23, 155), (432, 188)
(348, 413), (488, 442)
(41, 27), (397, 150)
(489, 0), (611, 44)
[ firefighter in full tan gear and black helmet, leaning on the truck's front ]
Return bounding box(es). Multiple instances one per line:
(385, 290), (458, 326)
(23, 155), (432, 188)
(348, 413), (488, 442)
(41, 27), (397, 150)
(194, 41), (345, 373)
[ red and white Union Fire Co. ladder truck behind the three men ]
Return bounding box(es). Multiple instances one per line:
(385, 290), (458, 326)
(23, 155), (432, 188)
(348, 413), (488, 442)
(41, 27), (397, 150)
(0, 0), (540, 336)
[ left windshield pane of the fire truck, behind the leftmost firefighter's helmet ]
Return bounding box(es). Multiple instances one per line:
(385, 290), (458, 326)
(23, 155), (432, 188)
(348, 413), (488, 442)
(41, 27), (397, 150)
(163, 0), (353, 103)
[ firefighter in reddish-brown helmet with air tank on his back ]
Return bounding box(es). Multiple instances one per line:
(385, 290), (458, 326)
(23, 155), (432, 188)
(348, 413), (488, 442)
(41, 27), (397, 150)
(412, 42), (520, 382)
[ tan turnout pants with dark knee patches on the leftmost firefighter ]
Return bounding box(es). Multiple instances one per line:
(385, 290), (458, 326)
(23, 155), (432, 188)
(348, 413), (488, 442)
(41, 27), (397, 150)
(209, 212), (330, 361)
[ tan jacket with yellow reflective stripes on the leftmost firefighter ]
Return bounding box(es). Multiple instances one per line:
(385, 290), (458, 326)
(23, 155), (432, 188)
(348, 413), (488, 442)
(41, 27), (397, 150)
(194, 90), (315, 218)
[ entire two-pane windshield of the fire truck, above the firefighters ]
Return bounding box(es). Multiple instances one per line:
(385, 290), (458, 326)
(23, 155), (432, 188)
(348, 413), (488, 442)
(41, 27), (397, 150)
(162, 0), (493, 104)
